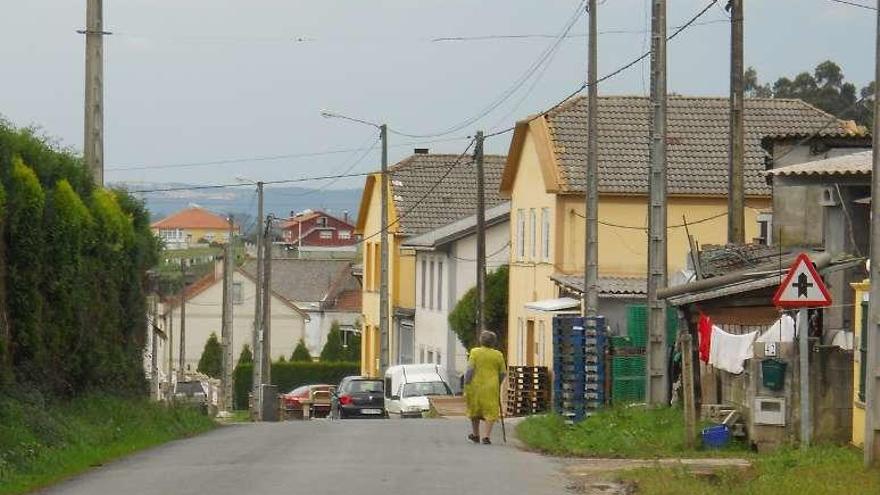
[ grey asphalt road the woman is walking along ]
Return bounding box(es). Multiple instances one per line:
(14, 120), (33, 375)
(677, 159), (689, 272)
(43, 419), (565, 495)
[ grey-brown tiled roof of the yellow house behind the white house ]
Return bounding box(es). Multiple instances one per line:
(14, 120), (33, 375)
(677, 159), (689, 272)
(389, 154), (506, 235)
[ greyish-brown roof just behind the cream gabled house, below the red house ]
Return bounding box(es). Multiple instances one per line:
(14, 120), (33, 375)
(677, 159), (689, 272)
(241, 258), (360, 303)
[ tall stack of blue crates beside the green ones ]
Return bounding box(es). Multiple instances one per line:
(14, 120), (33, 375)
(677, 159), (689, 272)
(553, 316), (608, 422)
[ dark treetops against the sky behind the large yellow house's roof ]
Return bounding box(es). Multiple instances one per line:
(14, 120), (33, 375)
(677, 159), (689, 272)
(744, 60), (874, 128)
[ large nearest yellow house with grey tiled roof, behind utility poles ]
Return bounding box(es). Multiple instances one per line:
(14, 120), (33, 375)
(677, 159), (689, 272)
(501, 96), (844, 365)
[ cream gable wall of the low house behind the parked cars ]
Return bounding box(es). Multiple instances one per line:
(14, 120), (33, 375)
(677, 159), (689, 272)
(166, 272), (305, 371)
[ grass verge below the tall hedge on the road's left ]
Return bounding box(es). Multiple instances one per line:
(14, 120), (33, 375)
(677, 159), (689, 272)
(0, 395), (215, 495)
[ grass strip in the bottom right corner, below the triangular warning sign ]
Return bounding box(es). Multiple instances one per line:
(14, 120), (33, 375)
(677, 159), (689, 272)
(617, 445), (880, 495)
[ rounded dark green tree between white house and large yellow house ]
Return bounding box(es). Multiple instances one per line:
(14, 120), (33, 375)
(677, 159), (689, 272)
(449, 265), (508, 352)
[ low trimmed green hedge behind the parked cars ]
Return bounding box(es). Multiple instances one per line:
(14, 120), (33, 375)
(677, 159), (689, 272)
(235, 361), (361, 409)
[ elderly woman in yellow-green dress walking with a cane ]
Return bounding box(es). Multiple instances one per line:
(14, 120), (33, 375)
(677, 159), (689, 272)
(464, 331), (507, 445)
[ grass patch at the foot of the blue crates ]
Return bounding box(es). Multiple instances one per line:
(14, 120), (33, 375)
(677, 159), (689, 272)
(516, 407), (746, 458)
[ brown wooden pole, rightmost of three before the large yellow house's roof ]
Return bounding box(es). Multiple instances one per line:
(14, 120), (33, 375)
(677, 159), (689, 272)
(727, 0), (746, 245)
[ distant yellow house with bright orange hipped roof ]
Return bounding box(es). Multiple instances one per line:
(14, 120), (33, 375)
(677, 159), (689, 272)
(150, 206), (238, 249)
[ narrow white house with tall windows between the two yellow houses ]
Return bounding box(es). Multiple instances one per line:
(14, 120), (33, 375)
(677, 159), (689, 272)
(401, 202), (510, 385)
